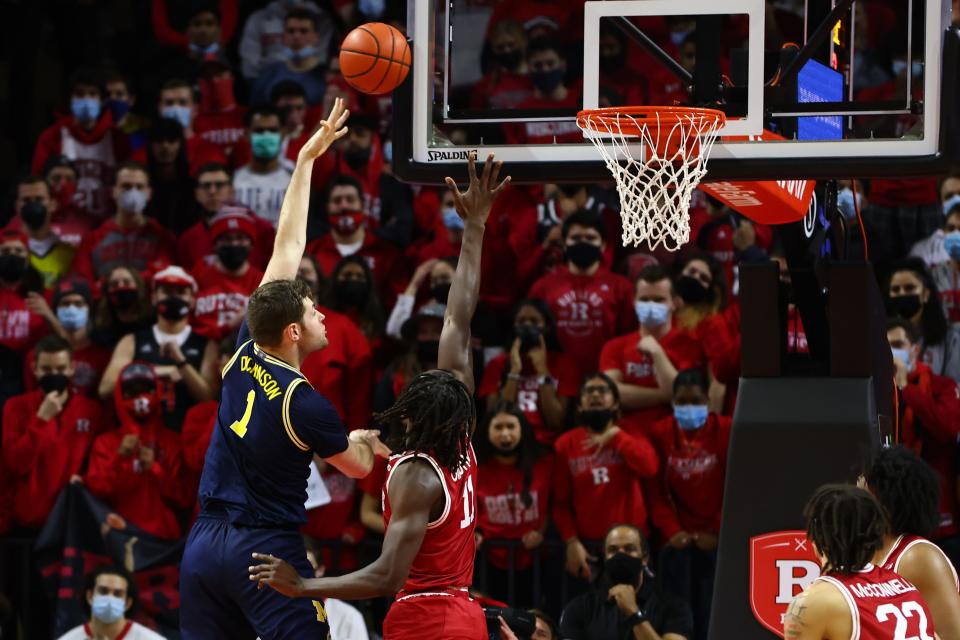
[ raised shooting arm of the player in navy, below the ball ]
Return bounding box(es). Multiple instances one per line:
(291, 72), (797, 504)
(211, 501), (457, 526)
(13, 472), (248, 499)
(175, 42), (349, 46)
(260, 98), (350, 284)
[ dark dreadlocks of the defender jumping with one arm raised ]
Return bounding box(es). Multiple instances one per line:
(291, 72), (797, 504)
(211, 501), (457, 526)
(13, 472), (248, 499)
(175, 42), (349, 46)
(374, 369), (475, 472)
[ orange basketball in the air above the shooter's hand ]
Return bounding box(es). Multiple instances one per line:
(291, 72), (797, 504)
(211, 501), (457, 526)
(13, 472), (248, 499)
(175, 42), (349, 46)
(340, 22), (410, 95)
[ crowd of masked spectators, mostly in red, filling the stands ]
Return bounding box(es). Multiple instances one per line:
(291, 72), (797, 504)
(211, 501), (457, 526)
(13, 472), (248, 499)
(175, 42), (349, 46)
(0, 0), (960, 640)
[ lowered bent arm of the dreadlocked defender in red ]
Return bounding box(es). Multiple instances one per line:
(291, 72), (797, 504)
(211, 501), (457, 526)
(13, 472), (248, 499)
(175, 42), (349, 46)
(250, 459), (443, 600)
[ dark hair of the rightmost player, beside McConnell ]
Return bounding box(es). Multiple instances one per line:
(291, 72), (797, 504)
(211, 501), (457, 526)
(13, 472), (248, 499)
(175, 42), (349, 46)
(864, 446), (940, 536)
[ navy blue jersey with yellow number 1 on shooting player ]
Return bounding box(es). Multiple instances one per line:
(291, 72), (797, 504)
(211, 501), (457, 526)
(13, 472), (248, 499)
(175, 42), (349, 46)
(199, 320), (348, 528)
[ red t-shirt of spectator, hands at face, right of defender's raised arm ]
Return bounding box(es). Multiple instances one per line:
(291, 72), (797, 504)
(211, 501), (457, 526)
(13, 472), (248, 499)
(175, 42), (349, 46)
(477, 351), (580, 446)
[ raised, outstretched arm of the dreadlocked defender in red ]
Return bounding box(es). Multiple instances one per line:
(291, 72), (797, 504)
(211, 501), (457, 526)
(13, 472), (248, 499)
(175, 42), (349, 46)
(437, 152), (510, 393)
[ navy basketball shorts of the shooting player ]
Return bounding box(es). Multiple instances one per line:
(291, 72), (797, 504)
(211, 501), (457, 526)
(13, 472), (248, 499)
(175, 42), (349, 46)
(180, 514), (330, 640)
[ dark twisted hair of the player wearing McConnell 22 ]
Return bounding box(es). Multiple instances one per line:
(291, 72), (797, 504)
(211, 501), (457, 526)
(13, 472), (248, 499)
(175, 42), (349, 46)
(803, 484), (887, 574)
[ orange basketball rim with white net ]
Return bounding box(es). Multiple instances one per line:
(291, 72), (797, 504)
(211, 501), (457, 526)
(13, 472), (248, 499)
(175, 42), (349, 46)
(577, 107), (726, 251)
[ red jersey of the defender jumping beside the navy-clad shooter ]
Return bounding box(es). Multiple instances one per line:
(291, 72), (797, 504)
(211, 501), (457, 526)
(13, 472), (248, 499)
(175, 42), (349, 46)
(383, 446), (477, 593)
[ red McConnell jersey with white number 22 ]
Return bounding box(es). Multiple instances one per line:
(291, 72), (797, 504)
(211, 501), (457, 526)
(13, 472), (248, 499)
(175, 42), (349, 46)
(817, 564), (933, 640)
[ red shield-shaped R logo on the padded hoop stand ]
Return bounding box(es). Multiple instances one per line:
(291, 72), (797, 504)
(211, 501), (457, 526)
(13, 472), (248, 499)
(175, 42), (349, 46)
(750, 531), (820, 638)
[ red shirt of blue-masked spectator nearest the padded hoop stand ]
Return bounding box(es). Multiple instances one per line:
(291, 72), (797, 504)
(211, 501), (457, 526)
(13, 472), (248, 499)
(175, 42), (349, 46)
(644, 414), (731, 540)
